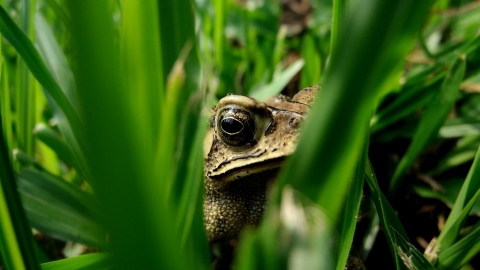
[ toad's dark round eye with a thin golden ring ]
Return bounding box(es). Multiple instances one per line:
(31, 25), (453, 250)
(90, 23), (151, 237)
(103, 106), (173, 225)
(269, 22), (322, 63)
(217, 108), (255, 146)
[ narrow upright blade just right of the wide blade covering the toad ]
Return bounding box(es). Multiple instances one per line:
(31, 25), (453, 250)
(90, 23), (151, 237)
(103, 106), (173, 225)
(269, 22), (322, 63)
(336, 125), (370, 270)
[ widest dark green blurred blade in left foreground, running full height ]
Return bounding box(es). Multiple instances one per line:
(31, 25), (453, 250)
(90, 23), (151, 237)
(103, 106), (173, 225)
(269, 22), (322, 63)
(67, 0), (193, 269)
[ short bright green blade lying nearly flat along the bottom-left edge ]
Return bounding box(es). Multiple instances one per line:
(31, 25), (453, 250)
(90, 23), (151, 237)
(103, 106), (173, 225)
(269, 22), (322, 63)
(41, 254), (112, 270)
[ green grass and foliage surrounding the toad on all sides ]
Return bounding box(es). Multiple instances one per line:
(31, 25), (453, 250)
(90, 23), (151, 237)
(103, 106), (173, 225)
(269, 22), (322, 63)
(0, 0), (480, 269)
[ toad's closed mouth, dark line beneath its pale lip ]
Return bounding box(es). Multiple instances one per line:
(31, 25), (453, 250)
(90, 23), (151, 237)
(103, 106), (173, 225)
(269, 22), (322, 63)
(207, 156), (285, 181)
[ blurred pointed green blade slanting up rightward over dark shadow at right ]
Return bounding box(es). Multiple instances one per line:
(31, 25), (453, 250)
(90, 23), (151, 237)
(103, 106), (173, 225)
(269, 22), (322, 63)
(390, 57), (466, 193)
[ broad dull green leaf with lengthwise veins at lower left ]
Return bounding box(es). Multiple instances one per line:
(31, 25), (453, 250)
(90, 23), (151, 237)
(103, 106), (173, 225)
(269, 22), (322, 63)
(18, 169), (106, 248)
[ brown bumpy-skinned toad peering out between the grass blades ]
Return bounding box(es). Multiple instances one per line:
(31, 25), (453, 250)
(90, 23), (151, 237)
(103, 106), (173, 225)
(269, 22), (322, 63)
(204, 86), (317, 242)
